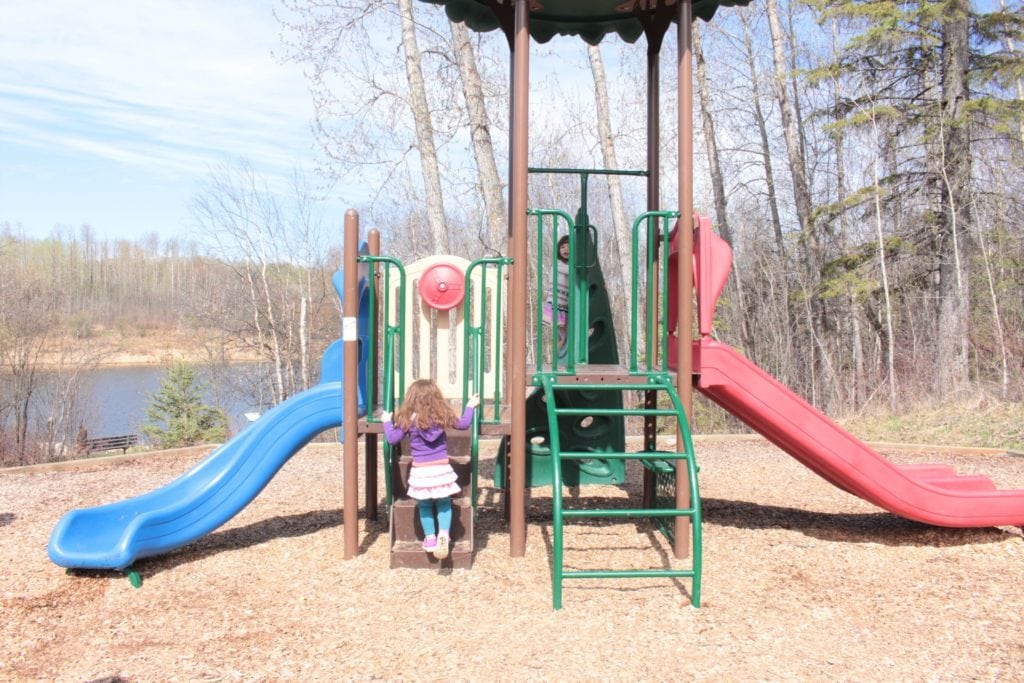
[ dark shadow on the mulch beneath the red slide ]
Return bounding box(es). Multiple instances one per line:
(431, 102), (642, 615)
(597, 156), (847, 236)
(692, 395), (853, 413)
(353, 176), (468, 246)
(701, 498), (1007, 547)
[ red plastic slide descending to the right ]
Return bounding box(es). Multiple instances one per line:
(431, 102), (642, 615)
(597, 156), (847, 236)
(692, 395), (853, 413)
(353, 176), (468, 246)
(669, 216), (1024, 526)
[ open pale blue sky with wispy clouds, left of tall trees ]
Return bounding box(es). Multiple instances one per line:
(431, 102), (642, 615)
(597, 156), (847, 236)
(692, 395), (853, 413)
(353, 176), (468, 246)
(0, 0), (342, 245)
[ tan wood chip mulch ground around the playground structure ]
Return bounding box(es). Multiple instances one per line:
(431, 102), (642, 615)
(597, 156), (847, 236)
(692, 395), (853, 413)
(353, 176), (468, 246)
(0, 438), (1024, 681)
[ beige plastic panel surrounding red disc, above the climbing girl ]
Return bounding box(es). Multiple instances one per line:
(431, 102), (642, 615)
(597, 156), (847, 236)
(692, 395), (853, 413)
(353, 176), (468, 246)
(390, 256), (508, 399)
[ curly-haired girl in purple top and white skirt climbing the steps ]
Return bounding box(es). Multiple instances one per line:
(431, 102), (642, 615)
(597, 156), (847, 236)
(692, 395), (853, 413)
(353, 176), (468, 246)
(381, 380), (480, 559)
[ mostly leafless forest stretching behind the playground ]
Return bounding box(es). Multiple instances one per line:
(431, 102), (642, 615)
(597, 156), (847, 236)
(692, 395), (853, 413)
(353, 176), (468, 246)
(0, 0), (1024, 464)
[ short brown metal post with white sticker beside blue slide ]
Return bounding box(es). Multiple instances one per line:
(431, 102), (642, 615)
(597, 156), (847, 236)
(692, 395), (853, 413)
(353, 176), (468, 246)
(341, 209), (359, 560)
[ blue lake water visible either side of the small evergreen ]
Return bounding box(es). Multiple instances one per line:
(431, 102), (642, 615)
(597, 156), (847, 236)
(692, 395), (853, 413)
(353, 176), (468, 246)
(80, 366), (259, 437)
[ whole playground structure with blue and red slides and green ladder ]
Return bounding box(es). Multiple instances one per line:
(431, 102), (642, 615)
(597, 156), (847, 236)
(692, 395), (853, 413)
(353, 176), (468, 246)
(49, 0), (1024, 608)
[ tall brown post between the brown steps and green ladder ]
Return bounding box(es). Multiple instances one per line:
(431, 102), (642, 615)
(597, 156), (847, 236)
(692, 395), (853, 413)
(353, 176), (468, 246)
(506, 0), (529, 557)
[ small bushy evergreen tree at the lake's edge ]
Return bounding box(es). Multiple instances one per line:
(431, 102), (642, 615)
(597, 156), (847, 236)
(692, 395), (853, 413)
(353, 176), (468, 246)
(142, 360), (227, 449)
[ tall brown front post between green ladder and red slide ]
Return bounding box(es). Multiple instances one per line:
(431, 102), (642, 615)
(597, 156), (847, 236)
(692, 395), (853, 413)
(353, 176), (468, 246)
(675, 0), (693, 558)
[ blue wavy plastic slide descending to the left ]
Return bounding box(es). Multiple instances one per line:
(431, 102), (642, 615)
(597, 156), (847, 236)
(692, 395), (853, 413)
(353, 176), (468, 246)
(47, 266), (369, 569)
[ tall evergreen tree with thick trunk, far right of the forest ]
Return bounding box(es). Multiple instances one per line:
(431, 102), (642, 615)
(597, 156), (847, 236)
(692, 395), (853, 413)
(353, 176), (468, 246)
(815, 0), (1022, 395)
